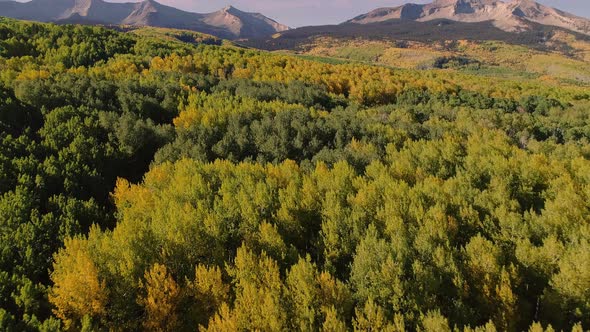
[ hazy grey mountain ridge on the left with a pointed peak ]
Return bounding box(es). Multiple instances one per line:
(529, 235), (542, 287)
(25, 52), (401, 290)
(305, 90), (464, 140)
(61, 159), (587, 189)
(0, 0), (289, 39)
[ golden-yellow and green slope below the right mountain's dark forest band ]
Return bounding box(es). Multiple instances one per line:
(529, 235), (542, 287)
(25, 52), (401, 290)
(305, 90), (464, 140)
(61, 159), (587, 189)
(276, 34), (590, 85)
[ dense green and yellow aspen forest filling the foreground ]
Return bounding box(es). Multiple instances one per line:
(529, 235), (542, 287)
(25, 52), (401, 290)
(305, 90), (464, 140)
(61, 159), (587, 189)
(0, 19), (590, 332)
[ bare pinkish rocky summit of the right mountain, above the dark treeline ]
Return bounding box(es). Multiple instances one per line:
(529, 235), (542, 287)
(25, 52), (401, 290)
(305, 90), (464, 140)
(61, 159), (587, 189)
(345, 0), (590, 35)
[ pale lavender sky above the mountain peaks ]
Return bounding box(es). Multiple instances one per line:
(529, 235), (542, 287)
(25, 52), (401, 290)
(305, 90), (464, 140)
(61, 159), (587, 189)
(107, 0), (590, 27)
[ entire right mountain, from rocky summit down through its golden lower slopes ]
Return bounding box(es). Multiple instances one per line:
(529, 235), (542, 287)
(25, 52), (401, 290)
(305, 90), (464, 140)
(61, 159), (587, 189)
(243, 0), (590, 85)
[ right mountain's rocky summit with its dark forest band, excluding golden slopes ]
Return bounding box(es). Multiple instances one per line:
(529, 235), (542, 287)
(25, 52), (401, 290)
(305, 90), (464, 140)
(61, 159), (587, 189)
(250, 0), (590, 53)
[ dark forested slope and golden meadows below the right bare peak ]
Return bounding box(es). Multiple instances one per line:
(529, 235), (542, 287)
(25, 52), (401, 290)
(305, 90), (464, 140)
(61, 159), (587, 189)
(242, 15), (590, 85)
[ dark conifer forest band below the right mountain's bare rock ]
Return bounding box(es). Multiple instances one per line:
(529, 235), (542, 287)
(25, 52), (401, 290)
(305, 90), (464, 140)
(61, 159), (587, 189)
(250, 19), (590, 53)
